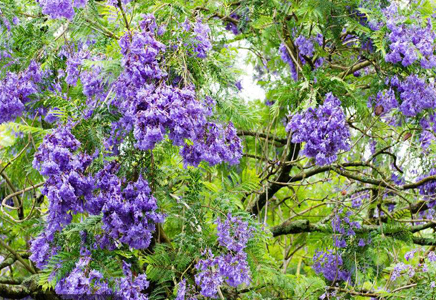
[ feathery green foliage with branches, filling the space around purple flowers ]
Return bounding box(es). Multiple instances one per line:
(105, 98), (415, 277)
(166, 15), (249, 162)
(0, 0), (436, 299)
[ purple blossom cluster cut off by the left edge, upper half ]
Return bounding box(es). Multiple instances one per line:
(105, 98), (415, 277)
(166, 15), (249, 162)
(0, 61), (43, 124)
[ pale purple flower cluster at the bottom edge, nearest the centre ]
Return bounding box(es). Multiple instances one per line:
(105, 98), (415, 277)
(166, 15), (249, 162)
(195, 214), (251, 298)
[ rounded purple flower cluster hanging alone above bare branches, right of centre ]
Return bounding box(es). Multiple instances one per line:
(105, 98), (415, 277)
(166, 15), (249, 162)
(286, 93), (350, 166)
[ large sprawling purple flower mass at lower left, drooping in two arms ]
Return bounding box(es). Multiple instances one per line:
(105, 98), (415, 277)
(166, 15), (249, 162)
(31, 124), (163, 267)
